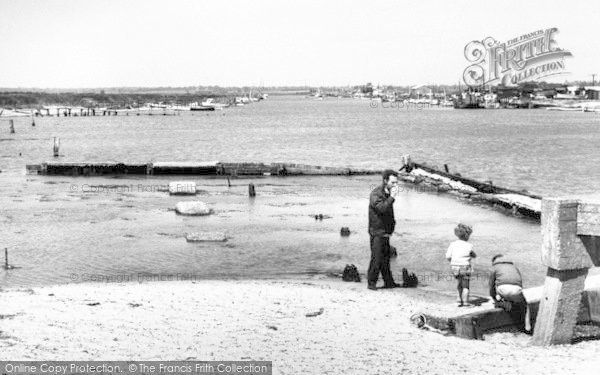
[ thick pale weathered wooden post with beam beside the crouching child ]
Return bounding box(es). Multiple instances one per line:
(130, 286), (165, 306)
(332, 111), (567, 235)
(533, 198), (600, 345)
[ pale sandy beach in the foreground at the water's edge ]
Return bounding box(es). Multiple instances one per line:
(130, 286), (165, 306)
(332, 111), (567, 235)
(0, 279), (600, 374)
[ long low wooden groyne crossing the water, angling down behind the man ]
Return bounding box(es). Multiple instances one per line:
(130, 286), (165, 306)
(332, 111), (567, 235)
(27, 156), (541, 220)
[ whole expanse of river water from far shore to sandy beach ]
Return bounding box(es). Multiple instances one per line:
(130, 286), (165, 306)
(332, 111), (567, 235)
(0, 97), (600, 293)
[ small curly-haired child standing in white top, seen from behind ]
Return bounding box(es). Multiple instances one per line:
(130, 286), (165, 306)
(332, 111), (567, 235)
(446, 223), (477, 306)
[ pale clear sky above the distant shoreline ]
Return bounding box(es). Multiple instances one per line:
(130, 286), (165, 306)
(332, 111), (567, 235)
(0, 0), (600, 88)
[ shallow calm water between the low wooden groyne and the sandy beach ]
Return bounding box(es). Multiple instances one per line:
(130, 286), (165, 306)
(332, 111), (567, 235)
(0, 176), (539, 294)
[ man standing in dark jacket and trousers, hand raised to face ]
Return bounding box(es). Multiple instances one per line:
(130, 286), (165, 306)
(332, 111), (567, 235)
(367, 169), (400, 290)
